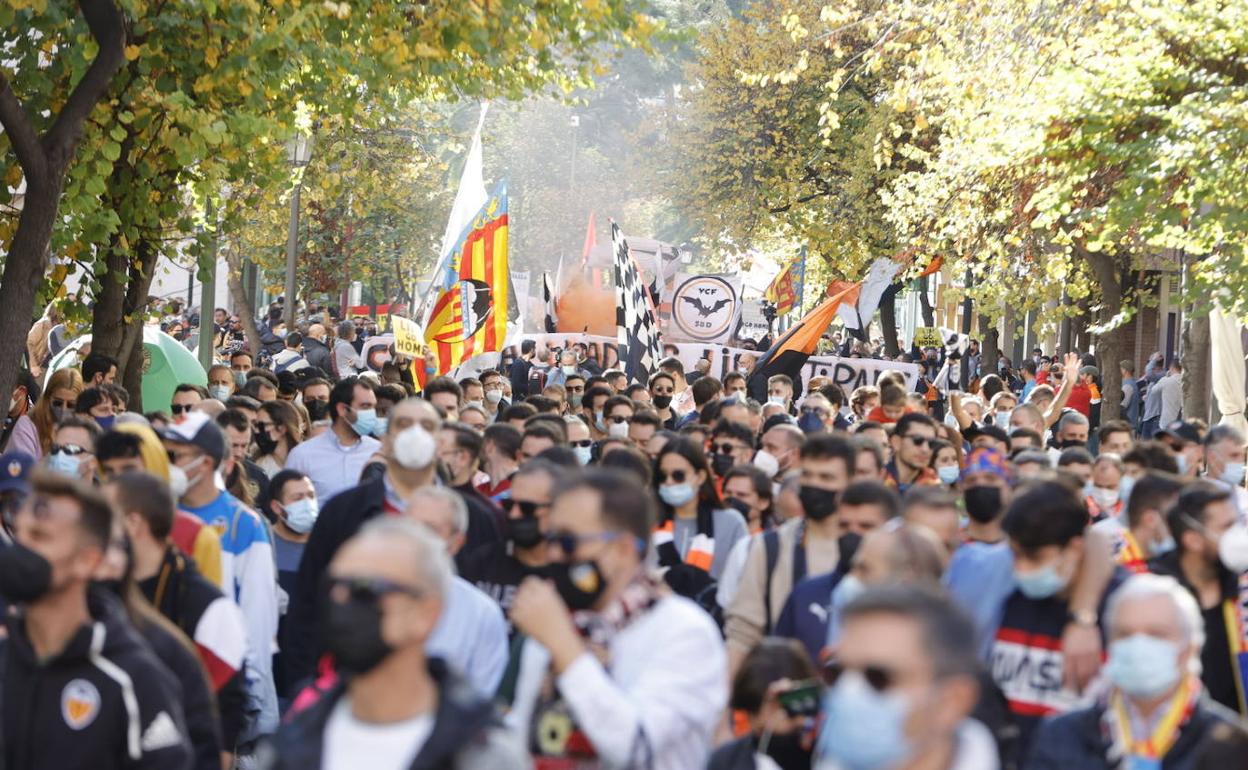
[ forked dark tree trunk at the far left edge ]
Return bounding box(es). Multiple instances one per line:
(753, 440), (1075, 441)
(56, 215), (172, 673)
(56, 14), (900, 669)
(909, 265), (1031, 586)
(0, 0), (126, 401)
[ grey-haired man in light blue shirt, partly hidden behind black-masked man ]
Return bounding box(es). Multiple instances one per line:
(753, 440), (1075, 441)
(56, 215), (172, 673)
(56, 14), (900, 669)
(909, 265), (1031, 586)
(407, 487), (508, 696)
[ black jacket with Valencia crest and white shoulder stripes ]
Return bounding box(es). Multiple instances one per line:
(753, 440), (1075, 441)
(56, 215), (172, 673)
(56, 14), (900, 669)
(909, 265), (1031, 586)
(0, 590), (192, 770)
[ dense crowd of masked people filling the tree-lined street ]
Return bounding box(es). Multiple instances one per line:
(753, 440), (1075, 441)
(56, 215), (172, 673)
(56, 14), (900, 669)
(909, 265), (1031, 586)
(0, 315), (1248, 770)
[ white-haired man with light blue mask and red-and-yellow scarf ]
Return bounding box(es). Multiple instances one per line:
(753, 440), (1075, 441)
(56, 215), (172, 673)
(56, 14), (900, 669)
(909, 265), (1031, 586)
(1026, 574), (1237, 770)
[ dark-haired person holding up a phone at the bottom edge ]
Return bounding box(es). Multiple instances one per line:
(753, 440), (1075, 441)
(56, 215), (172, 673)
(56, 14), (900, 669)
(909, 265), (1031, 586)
(706, 639), (819, 770)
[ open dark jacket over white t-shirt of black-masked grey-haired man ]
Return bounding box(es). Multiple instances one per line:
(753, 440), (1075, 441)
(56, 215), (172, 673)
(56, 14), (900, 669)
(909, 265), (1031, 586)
(260, 658), (529, 770)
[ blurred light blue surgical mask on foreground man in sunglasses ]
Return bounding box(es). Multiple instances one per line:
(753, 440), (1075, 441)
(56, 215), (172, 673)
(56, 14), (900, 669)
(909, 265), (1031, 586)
(815, 671), (914, 770)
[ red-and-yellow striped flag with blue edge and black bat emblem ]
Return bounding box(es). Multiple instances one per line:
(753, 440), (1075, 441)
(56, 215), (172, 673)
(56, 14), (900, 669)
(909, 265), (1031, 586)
(424, 181), (512, 374)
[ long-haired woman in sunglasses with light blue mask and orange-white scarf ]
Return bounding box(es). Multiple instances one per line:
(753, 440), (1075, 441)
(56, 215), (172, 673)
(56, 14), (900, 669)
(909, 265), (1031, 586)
(654, 437), (749, 598)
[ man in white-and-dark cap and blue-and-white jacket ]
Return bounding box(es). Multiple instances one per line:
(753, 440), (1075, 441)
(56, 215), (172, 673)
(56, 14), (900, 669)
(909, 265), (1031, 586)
(161, 412), (278, 740)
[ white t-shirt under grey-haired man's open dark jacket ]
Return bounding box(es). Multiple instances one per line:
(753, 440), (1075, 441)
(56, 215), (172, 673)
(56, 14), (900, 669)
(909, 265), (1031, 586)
(321, 696), (433, 770)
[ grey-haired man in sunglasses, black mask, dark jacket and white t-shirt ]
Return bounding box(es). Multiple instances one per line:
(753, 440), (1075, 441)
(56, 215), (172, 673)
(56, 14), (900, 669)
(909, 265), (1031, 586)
(260, 518), (529, 770)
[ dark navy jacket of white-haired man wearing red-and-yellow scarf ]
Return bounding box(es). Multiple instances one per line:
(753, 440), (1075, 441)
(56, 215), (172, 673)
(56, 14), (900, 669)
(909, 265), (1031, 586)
(1025, 696), (1237, 770)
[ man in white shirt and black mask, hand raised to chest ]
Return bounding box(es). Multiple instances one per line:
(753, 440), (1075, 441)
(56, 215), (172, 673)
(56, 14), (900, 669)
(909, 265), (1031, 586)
(503, 470), (728, 770)
